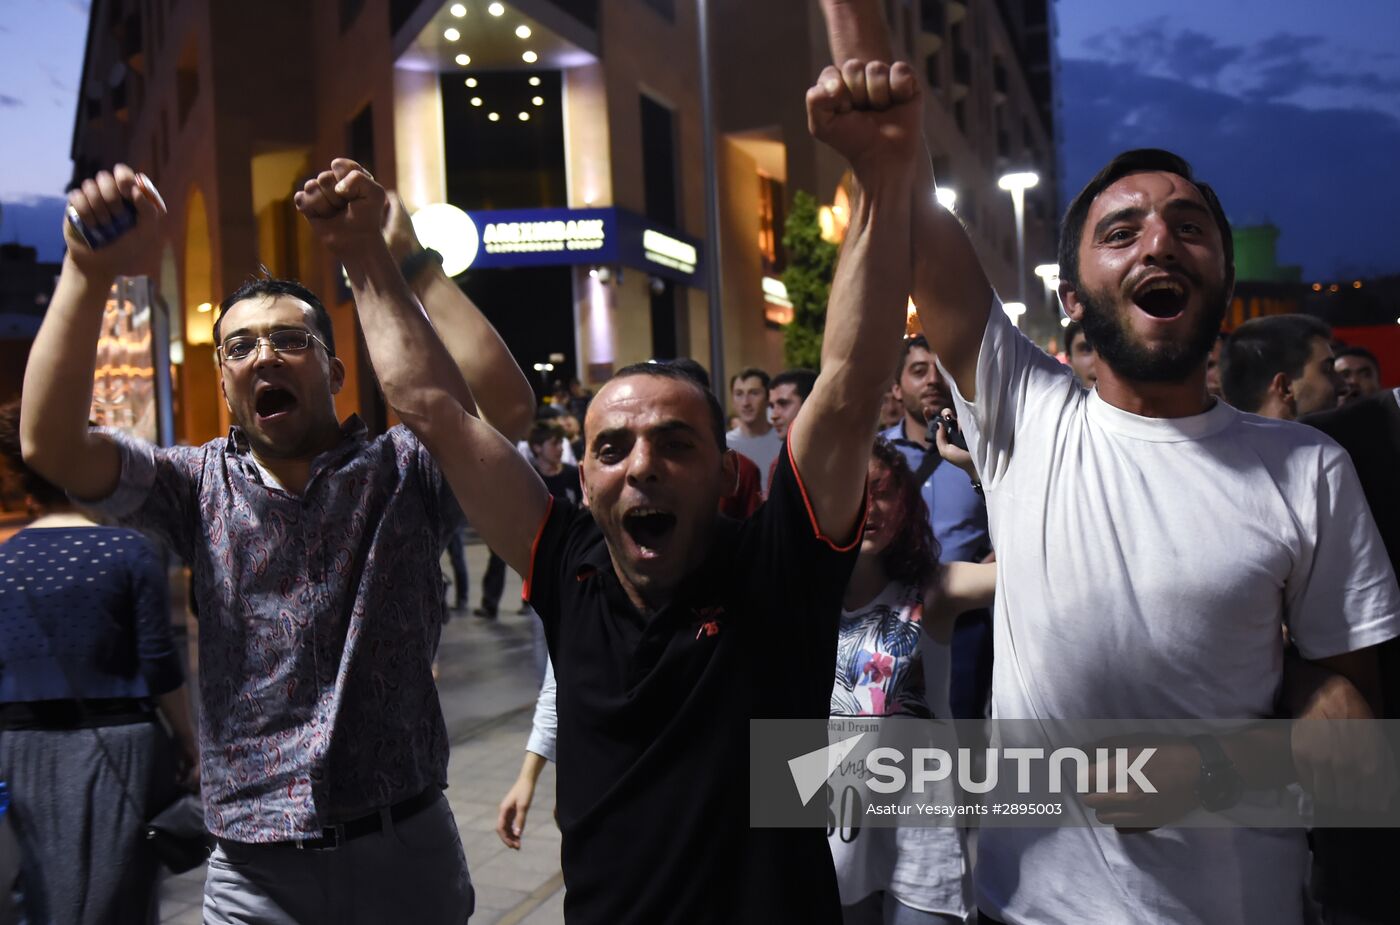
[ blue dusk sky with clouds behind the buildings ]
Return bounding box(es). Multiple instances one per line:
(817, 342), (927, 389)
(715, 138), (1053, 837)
(0, 0), (1400, 280)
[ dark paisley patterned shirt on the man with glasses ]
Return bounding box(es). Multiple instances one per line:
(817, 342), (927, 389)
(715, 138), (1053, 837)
(90, 417), (461, 842)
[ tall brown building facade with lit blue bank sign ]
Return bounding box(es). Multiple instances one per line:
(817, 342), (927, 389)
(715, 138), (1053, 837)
(73, 0), (1056, 442)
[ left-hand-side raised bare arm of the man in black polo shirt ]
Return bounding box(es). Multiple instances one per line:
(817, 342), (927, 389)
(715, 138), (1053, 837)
(295, 158), (549, 574)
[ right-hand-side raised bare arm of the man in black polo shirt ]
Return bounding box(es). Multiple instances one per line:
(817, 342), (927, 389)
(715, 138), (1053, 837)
(791, 62), (921, 539)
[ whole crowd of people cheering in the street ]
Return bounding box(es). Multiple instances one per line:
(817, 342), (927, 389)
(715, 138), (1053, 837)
(0, 0), (1400, 925)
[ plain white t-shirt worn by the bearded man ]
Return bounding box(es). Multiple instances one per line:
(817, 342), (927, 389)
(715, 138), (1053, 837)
(944, 304), (1400, 925)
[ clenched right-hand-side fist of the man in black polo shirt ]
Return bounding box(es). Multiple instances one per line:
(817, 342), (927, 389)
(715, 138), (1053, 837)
(806, 60), (923, 175)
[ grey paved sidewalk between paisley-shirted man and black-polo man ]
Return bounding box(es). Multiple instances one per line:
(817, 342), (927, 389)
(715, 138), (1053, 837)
(161, 544), (564, 925)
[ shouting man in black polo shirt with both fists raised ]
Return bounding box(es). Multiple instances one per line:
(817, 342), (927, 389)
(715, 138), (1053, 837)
(298, 55), (923, 925)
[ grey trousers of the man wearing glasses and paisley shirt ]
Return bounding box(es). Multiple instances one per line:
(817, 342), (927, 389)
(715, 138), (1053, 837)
(204, 798), (476, 925)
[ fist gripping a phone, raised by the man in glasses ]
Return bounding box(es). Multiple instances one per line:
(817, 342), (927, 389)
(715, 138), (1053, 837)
(63, 164), (165, 280)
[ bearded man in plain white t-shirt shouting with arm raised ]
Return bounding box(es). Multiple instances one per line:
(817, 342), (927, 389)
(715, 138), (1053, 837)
(823, 0), (1400, 925)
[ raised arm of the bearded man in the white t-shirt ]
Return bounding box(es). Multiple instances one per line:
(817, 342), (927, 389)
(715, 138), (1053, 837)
(822, 0), (991, 400)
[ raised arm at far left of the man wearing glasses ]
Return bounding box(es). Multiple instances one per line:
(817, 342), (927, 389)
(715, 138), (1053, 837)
(20, 164), (165, 500)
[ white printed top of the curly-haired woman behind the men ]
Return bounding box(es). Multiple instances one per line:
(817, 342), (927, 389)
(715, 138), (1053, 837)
(827, 582), (969, 918)
